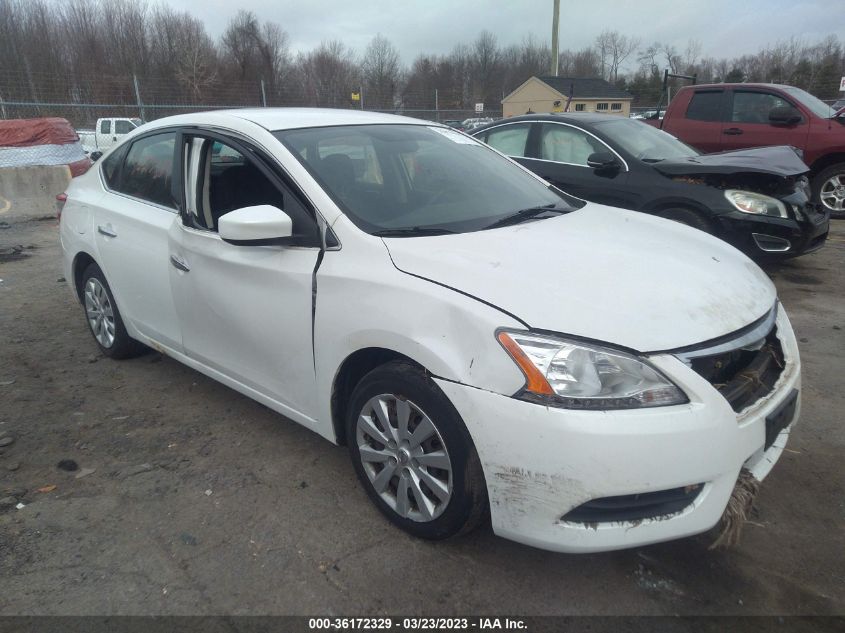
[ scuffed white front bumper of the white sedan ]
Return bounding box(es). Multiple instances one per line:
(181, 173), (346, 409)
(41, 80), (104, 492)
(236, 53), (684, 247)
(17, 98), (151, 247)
(437, 310), (801, 552)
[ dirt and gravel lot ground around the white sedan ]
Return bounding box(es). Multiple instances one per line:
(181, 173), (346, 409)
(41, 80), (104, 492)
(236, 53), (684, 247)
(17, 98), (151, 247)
(0, 211), (845, 615)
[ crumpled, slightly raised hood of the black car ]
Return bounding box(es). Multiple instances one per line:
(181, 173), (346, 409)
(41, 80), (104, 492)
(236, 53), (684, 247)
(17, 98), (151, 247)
(653, 145), (810, 177)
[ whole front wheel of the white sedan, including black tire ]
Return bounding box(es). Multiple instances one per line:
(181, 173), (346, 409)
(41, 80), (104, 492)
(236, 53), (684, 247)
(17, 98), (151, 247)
(346, 361), (487, 540)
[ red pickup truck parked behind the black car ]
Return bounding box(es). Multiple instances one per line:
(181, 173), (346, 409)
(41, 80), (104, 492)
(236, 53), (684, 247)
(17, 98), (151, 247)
(648, 84), (845, 216)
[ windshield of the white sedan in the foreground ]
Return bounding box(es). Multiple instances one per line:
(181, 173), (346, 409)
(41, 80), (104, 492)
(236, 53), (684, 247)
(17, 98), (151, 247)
(274, 124), (583, 234)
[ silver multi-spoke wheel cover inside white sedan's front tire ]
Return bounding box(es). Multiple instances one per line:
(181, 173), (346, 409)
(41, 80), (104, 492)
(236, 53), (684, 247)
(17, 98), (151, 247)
(355, 394), (452, 522)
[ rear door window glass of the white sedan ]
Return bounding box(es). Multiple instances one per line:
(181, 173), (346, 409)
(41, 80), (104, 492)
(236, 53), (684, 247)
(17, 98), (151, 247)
(113, 132), (177, 209)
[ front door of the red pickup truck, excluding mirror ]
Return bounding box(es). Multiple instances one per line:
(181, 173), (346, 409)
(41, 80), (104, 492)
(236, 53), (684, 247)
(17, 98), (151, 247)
(721, 88), (810, 150)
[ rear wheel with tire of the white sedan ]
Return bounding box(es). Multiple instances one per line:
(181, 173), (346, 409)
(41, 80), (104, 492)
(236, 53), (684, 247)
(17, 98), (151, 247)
(81, 264), (146, 359)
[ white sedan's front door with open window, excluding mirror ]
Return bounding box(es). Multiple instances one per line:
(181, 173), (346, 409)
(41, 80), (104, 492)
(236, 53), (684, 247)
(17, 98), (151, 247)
(170, 136), (320, 417)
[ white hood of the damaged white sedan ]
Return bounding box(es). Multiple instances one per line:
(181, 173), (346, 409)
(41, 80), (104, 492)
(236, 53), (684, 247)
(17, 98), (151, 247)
(384, 204), (776, 352)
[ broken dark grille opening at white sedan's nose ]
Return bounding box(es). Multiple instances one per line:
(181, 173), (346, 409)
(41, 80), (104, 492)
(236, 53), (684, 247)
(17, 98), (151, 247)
(692, 327), (784, 412)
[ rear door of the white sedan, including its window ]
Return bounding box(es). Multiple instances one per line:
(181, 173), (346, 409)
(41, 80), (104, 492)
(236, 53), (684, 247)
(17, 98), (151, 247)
(94, 131), (182, 351)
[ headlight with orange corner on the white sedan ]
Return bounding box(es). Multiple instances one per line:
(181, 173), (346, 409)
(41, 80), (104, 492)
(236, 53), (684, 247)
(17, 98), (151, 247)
(497, 330), (688, 409)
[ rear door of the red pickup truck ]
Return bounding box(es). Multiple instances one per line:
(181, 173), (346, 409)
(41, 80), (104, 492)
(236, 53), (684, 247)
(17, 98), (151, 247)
(663, 88), (726, 153)
